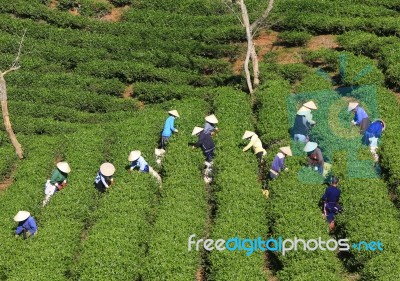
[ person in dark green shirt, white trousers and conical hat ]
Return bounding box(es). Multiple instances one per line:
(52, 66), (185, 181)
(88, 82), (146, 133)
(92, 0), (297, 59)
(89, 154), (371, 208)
(43, 162), (71, 207)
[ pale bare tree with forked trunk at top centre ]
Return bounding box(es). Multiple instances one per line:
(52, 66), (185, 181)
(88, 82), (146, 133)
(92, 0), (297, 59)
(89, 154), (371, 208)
(226, 0), (274, 94)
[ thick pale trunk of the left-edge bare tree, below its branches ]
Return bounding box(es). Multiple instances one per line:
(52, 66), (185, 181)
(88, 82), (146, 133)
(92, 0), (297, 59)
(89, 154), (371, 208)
(0, 72), (24, 159)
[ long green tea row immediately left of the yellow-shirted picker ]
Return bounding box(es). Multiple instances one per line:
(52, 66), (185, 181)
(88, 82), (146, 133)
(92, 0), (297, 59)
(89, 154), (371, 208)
(210, 88), (267, 280)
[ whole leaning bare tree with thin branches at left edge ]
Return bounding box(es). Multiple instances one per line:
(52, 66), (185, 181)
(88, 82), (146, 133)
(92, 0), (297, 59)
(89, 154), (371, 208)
(0, 30), (26, 159)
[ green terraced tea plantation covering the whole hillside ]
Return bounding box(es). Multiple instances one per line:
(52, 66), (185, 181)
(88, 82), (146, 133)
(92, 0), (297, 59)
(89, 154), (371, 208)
(0, 0), (400, 281)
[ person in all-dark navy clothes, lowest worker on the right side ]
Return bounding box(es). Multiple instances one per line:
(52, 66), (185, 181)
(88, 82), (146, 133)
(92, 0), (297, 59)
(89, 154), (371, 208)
(321, 177), (342, 231)
